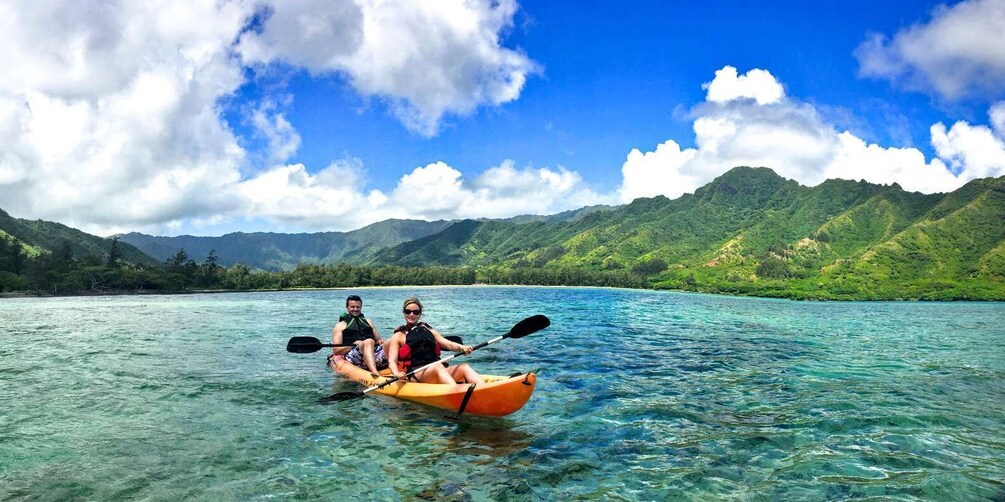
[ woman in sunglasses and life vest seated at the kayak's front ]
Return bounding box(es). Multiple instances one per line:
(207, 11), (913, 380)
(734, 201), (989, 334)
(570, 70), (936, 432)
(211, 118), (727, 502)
(387, 296), (485, 384)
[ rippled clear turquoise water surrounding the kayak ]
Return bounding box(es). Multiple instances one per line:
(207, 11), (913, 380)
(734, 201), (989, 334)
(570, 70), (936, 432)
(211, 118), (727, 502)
(0, 287), (1005, 500)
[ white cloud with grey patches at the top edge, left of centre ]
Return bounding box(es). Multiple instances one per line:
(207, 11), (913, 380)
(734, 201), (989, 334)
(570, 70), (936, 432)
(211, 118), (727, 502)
(238, 0), (537, 136)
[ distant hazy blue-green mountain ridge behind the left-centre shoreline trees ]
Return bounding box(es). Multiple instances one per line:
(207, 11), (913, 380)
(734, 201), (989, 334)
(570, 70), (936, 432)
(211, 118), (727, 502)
(119, 220), (451, 271)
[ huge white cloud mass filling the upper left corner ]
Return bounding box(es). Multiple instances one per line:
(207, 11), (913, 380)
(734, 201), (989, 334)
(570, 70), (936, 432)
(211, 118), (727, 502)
(0, 1), (250, 231)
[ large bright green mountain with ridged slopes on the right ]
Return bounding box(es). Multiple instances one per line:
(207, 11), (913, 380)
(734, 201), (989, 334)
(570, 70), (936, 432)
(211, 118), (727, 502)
(369, 168), (1005, 299)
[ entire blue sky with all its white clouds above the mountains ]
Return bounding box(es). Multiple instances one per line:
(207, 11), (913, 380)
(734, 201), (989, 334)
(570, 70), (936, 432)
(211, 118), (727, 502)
(0, 0), (1005, 236)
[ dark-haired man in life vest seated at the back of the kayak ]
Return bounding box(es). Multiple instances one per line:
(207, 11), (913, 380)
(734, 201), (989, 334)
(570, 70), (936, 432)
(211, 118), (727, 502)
(328, 294), (387, 378)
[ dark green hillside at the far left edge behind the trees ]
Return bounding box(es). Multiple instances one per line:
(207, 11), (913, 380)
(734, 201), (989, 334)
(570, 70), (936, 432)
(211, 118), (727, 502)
(0, 206), (159, 265)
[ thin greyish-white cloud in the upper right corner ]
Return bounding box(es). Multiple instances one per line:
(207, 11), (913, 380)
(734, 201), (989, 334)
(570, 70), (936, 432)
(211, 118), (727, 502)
(855, 0), (1005, 99)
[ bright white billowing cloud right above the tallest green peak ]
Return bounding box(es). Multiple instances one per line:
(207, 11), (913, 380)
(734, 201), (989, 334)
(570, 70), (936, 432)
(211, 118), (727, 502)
(618, 66), (1005, 202)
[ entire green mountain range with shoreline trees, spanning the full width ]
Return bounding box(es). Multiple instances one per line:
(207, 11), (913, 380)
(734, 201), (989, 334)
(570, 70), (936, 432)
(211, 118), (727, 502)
(0, 168), (1005, 300)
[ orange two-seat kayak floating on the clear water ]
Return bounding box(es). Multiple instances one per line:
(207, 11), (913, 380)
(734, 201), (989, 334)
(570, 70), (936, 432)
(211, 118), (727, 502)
(330, 355), (538, 417)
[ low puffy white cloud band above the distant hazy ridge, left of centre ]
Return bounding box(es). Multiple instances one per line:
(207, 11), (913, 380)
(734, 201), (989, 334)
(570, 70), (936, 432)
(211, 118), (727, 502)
(223, 159), (614, 232)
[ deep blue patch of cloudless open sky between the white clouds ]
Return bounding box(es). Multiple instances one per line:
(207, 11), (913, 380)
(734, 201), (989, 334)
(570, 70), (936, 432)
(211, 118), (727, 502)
(237, 1), (956, 190)
